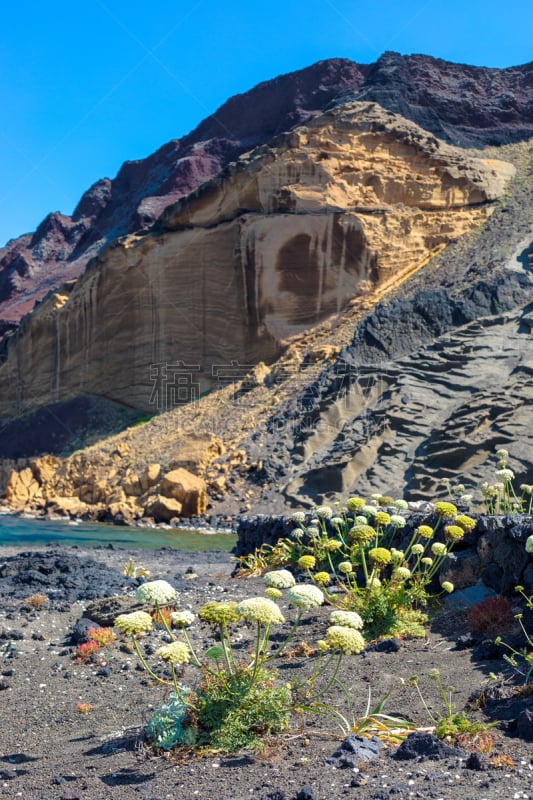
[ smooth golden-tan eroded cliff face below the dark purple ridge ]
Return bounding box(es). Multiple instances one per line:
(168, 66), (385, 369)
(0, 103), (513, 416)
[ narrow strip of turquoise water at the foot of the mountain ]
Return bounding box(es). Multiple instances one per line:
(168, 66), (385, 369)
(0, 515), (237, 552)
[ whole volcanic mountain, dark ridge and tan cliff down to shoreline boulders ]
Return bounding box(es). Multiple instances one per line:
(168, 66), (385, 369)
(0, 53), (533, 521)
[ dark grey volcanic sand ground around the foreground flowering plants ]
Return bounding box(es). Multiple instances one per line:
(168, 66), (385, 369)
(0, 547), (533, 800)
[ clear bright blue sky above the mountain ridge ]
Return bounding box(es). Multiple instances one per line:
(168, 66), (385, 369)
(0, 0), (533, 246)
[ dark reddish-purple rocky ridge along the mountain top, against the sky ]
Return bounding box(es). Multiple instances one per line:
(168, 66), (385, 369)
(0, 53), (533, 324)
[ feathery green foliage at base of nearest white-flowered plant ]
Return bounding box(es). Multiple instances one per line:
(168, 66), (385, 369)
(194, 667), (292, 753)
